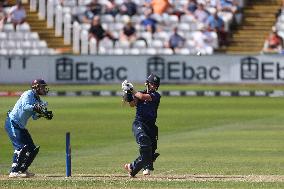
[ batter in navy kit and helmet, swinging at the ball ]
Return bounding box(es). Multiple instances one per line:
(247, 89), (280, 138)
(122, 74), (161, 177)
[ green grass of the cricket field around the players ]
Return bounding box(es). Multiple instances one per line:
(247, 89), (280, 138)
(0, 90), (284, 188)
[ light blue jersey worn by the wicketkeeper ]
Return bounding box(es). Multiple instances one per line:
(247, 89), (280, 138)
(9, 90), (42, 129)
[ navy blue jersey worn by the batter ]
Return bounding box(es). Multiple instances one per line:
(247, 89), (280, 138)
(136, 91), (161, 124)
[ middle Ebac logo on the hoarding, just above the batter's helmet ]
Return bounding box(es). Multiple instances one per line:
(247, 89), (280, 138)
(147, 56), (221, 81)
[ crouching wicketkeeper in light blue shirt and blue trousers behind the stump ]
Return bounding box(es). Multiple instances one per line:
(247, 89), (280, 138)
(5, 79), (53, 178)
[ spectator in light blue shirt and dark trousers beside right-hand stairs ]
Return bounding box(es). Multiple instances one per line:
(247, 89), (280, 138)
(206, 11), (228, 46)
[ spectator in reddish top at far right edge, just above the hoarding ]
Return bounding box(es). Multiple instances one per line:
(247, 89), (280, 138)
(263, 26), (283, 53)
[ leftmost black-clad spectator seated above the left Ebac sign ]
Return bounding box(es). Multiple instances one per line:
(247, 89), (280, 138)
(89, 16), (117, 52)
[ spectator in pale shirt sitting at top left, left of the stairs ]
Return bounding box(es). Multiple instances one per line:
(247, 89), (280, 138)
(9, 1), (27, 28)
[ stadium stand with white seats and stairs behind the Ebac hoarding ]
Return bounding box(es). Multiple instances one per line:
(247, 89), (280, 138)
(0, 0), (284, 55)
